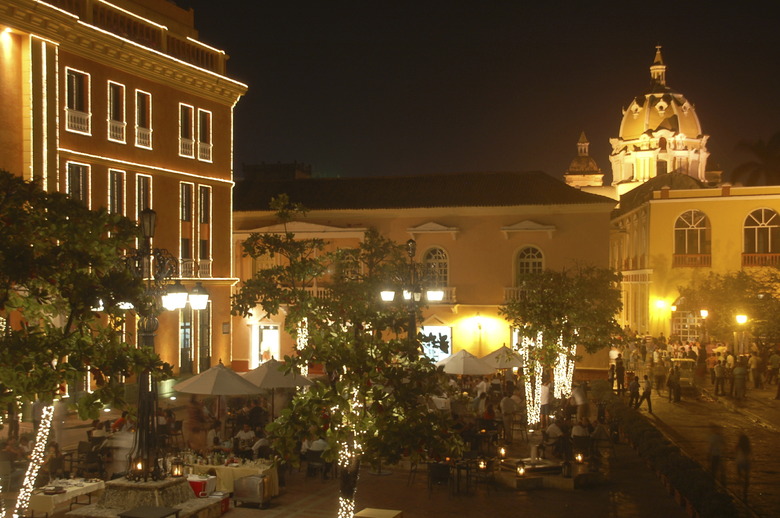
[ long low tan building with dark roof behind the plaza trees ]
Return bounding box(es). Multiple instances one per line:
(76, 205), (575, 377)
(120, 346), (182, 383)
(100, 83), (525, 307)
(233, 173), (615, 378)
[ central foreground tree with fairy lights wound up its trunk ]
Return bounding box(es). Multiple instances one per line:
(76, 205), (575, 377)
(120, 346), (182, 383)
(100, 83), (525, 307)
(233, 196), (459, 517)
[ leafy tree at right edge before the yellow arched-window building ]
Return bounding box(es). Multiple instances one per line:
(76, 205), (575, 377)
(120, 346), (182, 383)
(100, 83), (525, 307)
(678, 270), (780, 354)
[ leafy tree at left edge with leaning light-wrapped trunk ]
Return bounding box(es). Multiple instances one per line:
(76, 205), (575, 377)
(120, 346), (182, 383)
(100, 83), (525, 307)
(0, 171), (170, 514)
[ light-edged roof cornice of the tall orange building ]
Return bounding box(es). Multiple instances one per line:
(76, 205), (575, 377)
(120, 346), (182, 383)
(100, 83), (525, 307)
(0, 0), (247, 106)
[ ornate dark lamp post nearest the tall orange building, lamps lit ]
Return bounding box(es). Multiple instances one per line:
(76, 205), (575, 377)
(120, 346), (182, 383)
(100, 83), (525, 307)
(125, 209), (208, 481)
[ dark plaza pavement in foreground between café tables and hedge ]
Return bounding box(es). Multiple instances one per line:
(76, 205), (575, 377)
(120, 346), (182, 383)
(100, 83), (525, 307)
(221, 434), (687, 518)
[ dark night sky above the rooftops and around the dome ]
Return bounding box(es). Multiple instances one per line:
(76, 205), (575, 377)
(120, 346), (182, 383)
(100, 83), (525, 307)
(178, 0), (780, 183)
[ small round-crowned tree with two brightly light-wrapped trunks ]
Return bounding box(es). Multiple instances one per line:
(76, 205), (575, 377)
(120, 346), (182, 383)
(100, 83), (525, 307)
(499, 266), (622, 423)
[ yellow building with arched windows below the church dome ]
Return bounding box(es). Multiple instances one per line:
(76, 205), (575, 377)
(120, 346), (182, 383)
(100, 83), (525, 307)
(610, 178), (780, 340)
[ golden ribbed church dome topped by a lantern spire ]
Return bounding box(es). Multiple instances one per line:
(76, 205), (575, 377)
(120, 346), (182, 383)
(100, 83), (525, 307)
(619, 47), (702, 141)
